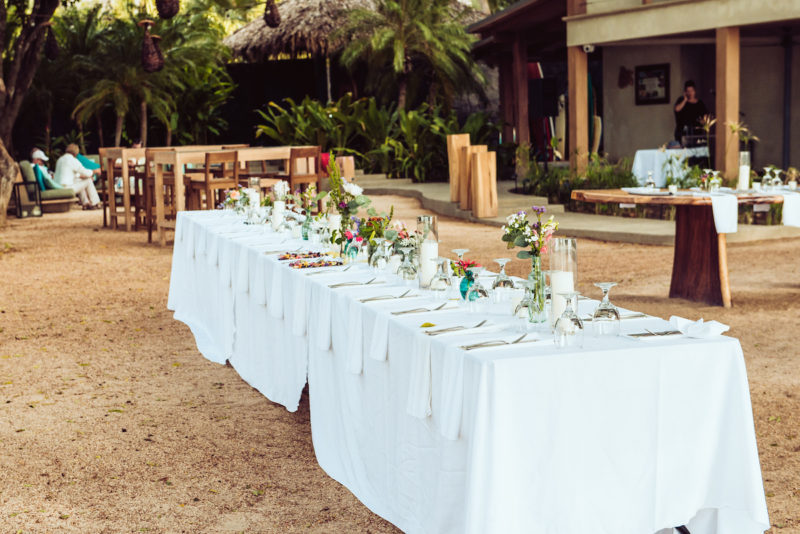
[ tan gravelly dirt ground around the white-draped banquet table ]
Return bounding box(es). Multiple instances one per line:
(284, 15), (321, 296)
(0, 197), (800, 533)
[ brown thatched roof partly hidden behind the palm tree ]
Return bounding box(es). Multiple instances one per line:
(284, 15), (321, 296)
(223, 0), (484, 62)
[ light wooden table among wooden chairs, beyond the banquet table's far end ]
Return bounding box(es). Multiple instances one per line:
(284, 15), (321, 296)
(150, 146), (293, 245)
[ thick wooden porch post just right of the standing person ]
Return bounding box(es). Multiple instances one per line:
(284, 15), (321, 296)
(714, 28), (739, 180)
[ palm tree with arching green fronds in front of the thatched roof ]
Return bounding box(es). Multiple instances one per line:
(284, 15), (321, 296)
(342, 0), (483, 109)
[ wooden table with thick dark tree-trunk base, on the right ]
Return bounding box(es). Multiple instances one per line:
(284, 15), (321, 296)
(572, 189), (783, 308)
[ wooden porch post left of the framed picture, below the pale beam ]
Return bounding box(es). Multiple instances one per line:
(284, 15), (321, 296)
(566, 46), (589, 174)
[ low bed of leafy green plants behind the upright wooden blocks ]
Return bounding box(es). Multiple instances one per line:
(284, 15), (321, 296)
(256, 94), (498, 182)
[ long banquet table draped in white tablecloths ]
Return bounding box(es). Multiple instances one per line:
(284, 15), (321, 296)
(168, 211), (769, 534)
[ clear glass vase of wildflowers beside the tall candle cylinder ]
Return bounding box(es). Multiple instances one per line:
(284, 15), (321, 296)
(503, 206), (558, 323)
